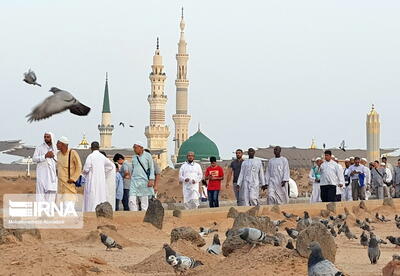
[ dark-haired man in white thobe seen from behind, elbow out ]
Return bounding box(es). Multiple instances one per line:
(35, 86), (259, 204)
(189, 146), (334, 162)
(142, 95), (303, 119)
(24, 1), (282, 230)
(82, 142), (115, 212)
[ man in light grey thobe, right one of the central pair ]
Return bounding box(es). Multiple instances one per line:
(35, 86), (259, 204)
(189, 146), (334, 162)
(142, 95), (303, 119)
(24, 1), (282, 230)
(265, 146), (290, 205)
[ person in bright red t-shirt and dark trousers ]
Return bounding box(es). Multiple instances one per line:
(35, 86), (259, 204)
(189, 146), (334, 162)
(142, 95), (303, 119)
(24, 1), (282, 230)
(205, 157), (224, 208)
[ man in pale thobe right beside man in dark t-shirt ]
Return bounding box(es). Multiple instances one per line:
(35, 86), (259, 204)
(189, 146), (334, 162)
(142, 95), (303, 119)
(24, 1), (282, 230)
(236, 148), (265, 206)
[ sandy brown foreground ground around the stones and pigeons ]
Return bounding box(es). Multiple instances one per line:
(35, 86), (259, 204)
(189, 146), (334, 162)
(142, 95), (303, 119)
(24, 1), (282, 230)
(0, 200), (400, 276)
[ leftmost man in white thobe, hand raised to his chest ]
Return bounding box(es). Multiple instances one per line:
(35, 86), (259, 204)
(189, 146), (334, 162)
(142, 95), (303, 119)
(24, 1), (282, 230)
(32, 132), (58, 202)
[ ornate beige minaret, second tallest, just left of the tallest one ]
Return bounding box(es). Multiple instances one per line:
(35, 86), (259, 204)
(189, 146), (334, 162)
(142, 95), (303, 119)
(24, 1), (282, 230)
(145, 38), (169, 170)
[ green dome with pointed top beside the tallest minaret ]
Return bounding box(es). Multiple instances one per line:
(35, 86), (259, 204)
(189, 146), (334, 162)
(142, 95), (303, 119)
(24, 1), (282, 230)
(177, 130), (220, 163)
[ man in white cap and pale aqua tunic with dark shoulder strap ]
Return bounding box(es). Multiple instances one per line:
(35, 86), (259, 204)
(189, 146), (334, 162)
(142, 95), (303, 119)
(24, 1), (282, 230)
(129, 142), (155, 211)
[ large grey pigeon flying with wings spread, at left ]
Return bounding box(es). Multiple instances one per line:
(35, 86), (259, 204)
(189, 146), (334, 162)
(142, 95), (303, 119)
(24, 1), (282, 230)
(26, 87), (90, 122)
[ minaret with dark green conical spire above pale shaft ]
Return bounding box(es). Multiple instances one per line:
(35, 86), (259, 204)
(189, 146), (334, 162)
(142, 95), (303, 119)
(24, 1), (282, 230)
(98, 73), (114, 149)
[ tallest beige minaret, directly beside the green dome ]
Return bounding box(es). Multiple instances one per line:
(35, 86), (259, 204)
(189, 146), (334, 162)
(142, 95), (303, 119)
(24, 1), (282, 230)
(172, 8), (190, 163)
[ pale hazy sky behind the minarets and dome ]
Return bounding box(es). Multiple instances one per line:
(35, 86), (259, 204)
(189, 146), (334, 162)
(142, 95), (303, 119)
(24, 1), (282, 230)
(0, 0), (400, 161)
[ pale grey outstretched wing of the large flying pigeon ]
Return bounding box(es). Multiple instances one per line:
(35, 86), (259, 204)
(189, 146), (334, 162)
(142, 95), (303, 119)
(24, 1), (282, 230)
(27, 91), (76, 122)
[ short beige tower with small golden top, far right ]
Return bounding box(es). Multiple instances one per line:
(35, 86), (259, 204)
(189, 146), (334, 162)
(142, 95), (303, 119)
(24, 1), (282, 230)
(367, 105), (381, 162)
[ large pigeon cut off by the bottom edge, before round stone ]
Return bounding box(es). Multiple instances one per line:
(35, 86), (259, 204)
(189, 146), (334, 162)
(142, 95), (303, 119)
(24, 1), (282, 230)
(308, 241), (344, 276)
